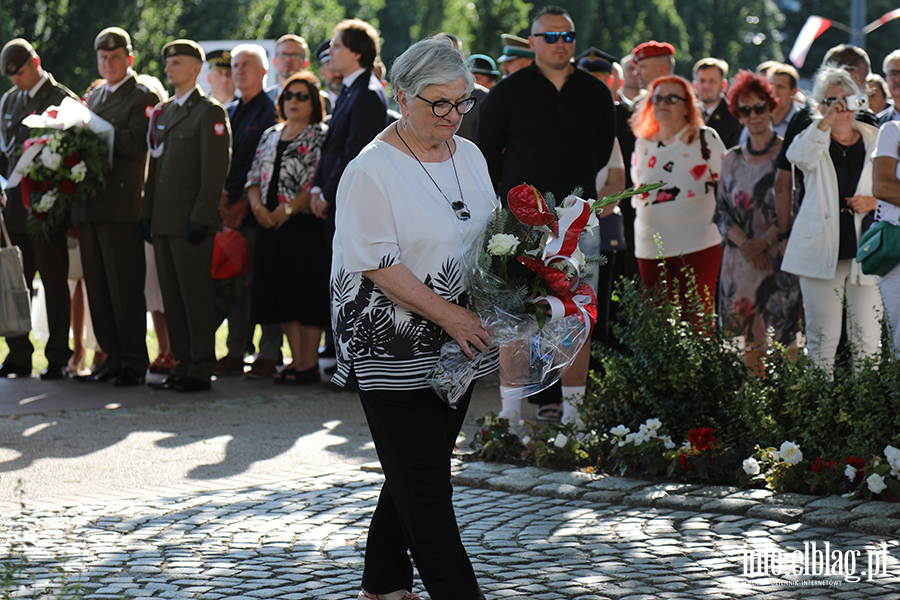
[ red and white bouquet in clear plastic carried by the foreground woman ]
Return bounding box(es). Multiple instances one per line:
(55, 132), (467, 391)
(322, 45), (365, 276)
(428, 184), (658, 407)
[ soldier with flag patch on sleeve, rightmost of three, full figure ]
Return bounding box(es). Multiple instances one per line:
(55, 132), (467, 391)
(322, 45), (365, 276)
(140, 40), (231, 392)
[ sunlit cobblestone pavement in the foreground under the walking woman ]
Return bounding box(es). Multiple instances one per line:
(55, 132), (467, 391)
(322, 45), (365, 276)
(0, 463), (900, 600)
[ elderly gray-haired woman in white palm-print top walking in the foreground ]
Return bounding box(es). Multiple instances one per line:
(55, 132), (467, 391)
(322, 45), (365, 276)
(331, 38), (497, 600)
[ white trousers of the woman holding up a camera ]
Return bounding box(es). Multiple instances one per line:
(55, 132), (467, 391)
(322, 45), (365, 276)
(800, 259), (882, 372)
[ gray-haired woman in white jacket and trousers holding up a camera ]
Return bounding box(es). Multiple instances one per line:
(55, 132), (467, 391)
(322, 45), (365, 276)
(781, 64), (881, 371)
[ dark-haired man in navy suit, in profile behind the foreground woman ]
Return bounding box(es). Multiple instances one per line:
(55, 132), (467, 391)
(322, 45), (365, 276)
(310, 19), (387, 225)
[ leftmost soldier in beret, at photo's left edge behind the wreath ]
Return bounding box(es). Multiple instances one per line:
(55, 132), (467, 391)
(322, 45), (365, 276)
(0, 39), (78, 379)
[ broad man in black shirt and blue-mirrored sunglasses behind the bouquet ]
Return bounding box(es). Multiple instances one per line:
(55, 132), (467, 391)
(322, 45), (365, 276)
(477, 6), (616, 420)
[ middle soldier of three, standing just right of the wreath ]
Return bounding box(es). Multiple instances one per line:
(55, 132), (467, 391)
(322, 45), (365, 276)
(72, 27), (162, 386)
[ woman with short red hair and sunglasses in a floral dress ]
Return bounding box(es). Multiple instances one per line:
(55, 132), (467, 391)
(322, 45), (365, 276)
(715, 71), (803, 375)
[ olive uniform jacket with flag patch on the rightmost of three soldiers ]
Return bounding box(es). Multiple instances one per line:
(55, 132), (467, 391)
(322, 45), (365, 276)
(141, 87), (231, 236)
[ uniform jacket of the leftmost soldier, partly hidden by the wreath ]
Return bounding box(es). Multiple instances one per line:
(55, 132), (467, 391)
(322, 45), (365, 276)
(0, 73), (80, 233)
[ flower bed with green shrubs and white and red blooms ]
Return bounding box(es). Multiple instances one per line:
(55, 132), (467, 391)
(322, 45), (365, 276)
(473, 268), (900, 499)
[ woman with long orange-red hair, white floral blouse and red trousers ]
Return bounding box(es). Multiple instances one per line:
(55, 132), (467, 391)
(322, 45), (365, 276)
(631, 77), (725, 312)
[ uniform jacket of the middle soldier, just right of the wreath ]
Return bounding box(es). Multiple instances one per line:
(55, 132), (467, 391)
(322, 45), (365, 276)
(72, 76), (162, 223)
